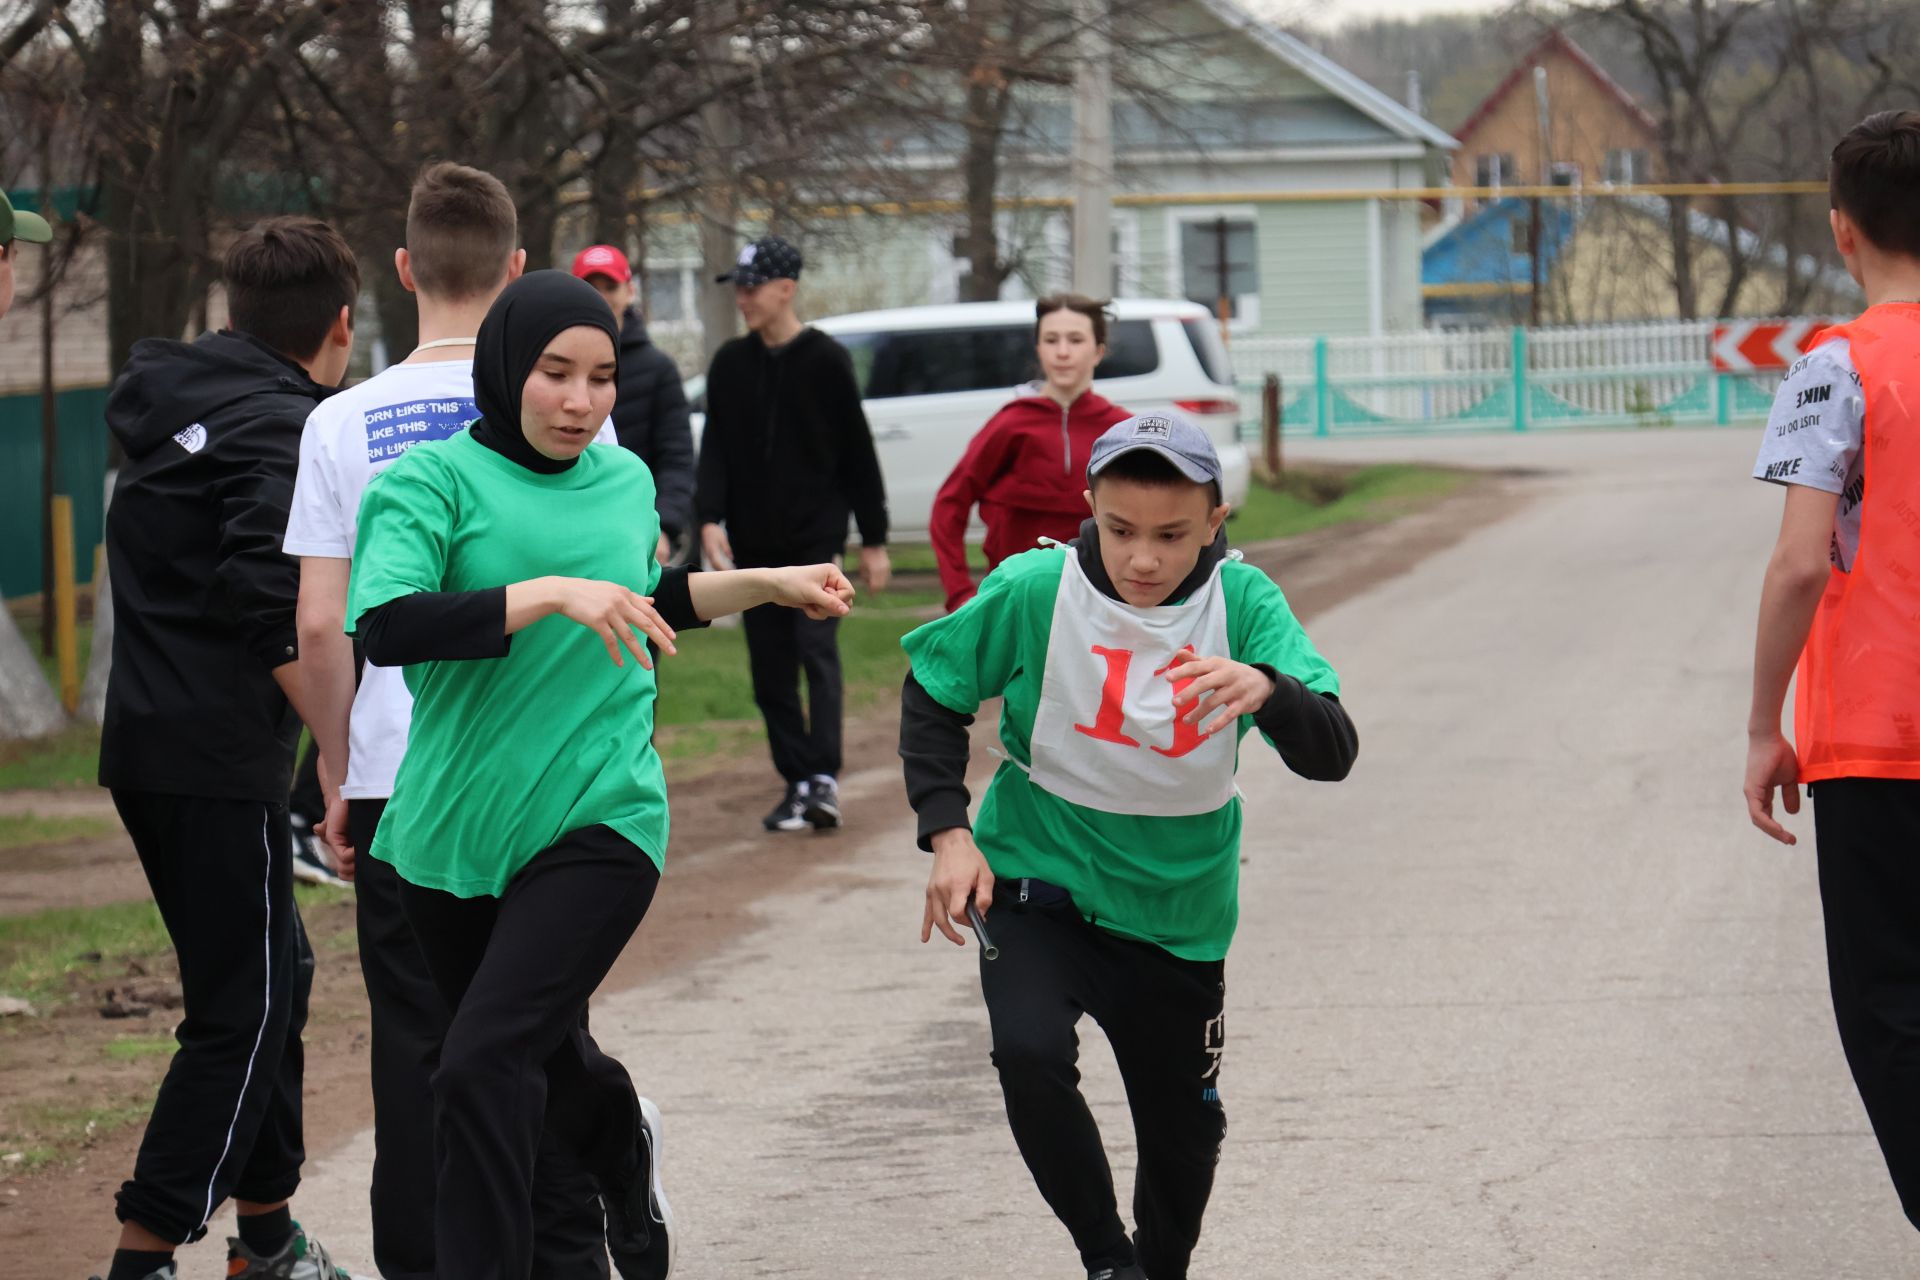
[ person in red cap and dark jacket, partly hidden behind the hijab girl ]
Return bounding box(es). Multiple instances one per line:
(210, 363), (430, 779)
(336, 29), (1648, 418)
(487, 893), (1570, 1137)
(574, 244), (693, 564)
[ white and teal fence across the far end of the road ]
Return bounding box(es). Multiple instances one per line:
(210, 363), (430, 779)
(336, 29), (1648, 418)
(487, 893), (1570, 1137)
(1233, 320), (1780, 438)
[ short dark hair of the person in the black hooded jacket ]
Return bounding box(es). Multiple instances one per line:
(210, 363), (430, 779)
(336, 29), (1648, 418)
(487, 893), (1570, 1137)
(221, 217), (359, 361)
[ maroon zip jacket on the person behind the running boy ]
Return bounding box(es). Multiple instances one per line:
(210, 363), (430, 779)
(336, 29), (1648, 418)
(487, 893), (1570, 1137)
(927, 391), (1131, 612)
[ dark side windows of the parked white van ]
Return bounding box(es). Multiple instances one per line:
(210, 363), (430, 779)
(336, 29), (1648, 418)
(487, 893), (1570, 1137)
(833, 320), (1160, 399)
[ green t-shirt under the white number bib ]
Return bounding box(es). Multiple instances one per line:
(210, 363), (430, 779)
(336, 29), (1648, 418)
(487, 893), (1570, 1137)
(900, 547), (1340, 960)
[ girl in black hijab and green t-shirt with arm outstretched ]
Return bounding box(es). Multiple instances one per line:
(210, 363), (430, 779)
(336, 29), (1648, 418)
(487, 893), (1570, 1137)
(348, 271), (852, 1280)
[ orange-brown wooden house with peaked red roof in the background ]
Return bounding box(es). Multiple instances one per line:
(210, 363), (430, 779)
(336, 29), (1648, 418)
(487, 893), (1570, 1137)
(1453, 31), (1661, 186)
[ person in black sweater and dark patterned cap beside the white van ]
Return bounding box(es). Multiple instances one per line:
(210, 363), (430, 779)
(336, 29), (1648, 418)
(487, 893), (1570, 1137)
(695, 236), (891, 831)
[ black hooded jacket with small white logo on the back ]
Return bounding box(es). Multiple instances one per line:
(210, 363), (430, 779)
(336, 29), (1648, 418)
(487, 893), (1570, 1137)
(100, 330), (332, 802)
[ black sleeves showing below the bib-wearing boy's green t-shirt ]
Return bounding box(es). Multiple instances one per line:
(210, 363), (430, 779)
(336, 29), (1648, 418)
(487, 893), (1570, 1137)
(900, 662), (1359, 850)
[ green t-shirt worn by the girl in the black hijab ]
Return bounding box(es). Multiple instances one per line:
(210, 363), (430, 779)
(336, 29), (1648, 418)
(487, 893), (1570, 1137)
(348, 432), (666, 898)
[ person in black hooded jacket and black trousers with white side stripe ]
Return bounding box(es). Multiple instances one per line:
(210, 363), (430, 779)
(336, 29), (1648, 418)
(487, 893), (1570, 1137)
(100, 217), (359, 1280)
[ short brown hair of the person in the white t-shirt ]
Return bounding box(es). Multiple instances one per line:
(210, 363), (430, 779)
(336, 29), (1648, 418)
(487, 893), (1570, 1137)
(407, 161), (520, 301)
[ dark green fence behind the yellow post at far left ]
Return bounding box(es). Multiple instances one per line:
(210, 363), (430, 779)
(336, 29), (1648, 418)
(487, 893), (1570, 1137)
(0, 388), (108, 597)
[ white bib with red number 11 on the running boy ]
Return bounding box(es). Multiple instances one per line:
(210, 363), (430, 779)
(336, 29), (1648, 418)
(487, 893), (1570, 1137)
(1029, 547), (1238, 818)
